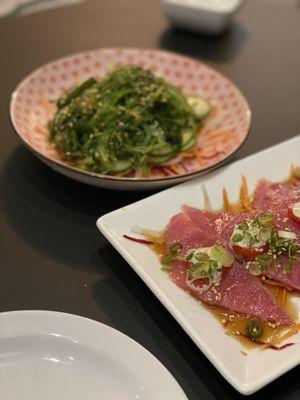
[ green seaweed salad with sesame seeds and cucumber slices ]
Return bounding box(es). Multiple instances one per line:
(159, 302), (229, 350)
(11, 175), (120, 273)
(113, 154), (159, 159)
(48, 65), (211, 177)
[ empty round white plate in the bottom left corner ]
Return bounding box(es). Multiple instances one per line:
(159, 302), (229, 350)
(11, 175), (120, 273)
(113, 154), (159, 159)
(0, 311), (186, 400)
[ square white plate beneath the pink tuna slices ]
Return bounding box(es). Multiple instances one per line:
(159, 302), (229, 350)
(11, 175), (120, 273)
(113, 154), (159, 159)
(97, 136), (300, 394)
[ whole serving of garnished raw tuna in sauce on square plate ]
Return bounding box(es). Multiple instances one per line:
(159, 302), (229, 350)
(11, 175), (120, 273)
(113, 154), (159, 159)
(126, 167), (300, 350)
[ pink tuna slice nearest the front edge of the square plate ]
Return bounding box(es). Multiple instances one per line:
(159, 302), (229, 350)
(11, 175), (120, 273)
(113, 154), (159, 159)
(171, 261), (294, 325)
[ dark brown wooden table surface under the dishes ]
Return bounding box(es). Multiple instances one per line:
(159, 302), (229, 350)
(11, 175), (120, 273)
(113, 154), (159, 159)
(0, 0), (300, 400)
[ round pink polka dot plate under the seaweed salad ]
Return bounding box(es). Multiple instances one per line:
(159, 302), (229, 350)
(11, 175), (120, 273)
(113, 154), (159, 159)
(10, 48), (251, 190)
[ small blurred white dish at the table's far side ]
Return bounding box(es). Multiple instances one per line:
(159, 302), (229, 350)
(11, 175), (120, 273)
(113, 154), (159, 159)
(162, 0), (243, 34)
